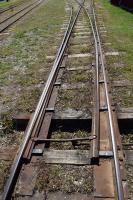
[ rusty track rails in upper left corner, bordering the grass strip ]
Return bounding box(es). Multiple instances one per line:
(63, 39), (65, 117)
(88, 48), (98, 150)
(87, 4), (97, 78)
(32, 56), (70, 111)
(0, 0), (42, 33)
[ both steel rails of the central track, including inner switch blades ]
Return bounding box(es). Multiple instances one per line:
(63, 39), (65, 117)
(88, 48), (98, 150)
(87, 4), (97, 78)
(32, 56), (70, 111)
(3, 1), (124, 200)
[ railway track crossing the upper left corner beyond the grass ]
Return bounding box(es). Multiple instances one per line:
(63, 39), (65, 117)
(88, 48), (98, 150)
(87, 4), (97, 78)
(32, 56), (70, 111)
(0, 0), (42, 33)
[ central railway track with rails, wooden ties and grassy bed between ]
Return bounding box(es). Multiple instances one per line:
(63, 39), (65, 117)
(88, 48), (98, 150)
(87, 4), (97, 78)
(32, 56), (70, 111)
(3, 1), (128, 200)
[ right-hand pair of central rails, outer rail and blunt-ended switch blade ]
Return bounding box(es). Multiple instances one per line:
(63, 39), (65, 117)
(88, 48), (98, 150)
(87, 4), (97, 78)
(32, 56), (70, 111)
(76, 0), (124, 200)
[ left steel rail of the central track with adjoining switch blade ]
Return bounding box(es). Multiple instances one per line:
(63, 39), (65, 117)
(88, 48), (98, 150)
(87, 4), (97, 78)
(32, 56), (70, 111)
(2, 3), (82, 200)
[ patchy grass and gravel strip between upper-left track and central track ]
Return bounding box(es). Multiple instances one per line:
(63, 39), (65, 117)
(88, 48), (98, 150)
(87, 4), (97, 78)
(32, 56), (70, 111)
(0, 0), (65, 131)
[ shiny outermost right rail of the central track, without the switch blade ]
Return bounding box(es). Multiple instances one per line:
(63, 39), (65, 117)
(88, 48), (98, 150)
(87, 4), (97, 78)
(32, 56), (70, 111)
(92, 7), (124, 200)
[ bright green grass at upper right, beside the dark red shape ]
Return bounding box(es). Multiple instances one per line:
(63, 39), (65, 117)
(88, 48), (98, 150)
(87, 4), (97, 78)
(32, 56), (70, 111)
(96, 0), (133, 81)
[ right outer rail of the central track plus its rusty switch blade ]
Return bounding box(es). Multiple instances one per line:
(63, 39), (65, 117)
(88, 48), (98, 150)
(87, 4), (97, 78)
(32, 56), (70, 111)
(76, 0), (124, 200)
